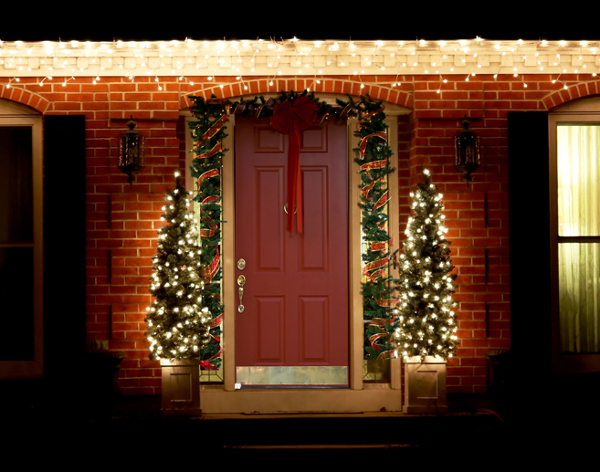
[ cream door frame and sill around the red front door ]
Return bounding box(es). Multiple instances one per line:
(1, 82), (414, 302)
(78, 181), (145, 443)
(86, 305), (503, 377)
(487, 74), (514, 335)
(186, 94), (410, 413)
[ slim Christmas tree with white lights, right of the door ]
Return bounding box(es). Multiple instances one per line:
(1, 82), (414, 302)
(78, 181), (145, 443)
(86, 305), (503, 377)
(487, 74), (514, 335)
(395, 169), (458, 360)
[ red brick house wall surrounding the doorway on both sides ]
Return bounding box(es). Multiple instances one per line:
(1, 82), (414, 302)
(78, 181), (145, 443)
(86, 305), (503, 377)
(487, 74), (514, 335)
(0, 75), (600, 394)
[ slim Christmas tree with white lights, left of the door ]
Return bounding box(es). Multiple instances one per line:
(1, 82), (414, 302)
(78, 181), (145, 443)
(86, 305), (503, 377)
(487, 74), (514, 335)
(145, 172), (211, 360)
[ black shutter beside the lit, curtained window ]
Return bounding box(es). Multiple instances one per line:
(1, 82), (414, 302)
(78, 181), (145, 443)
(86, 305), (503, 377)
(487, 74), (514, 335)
(508, 112), (552, 368)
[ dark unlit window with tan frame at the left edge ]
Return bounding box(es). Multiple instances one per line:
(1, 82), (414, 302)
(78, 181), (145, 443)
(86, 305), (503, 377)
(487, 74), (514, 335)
(0, 100), (43, 378)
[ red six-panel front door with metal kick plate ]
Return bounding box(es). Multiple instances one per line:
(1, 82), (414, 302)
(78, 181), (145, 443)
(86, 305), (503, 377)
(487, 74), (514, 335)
(235, 118), (349, 387)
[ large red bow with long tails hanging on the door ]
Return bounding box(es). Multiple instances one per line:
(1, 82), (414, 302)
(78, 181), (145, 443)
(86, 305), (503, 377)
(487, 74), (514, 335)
(271, 95), (318, 234)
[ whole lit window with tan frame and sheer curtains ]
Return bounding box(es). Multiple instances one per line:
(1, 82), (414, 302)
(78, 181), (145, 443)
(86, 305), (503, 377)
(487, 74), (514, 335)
(550, 108), (600, 371)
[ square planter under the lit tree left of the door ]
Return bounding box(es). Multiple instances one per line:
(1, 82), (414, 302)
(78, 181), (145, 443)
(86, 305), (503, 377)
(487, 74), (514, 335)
(160, 359), (202, 416)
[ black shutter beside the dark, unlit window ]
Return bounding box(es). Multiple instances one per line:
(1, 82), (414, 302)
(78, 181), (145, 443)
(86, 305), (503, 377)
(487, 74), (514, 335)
(44, 115), (86, 379)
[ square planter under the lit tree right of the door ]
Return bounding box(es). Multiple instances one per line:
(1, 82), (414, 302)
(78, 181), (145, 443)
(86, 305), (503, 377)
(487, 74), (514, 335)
(403, 356), (448, 414)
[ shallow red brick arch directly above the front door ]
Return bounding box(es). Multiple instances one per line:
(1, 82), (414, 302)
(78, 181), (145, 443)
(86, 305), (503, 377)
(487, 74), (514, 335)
(180, 77), (413, 109)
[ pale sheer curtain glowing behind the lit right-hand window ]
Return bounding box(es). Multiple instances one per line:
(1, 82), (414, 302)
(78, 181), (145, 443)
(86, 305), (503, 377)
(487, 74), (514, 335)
(557, 124), (600, 353)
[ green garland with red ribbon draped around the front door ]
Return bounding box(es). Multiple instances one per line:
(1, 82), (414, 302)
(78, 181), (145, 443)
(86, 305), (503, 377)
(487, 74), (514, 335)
(189, 91), (394, 366)
